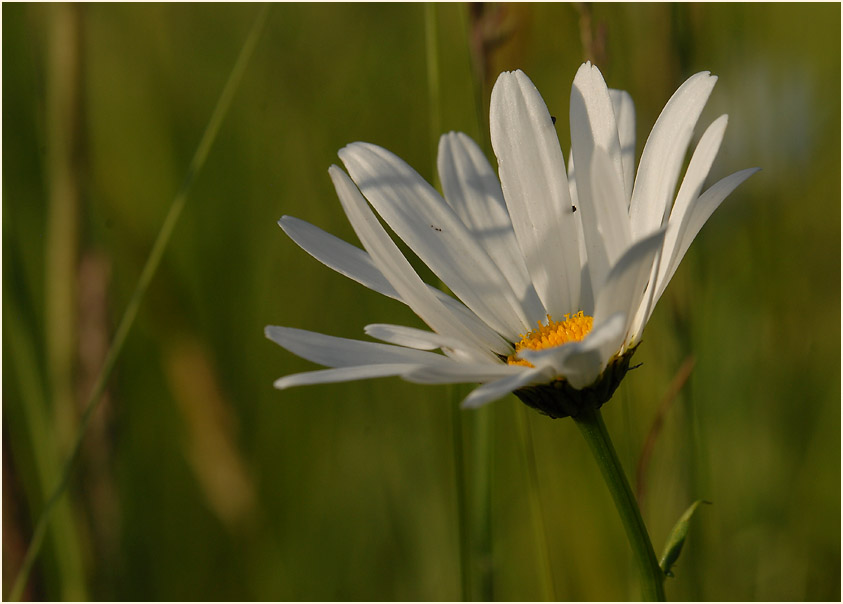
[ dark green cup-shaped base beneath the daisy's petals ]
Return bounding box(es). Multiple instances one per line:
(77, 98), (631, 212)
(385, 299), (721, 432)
(515, 346), (637, 419)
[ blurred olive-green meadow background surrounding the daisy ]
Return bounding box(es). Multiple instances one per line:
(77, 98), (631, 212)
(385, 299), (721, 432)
(2, 3), (841, 600)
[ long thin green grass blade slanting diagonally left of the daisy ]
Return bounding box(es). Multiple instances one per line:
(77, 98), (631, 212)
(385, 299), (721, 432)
(9, 5), (269, 600)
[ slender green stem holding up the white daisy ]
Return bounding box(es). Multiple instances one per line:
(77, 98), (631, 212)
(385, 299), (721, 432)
(573, 408), (665, 602)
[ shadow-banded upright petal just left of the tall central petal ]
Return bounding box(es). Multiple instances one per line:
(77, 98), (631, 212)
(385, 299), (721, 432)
(437, 132), (547, 325)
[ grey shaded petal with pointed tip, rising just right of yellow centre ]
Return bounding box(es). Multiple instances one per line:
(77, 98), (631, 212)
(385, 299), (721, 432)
(594, 230), (664, 354)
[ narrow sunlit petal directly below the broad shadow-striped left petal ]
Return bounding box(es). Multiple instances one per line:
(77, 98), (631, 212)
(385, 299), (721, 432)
(329, 166), (494, 358)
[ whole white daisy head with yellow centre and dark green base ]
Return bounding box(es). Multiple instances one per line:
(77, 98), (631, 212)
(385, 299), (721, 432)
(266, 63), (755, 417)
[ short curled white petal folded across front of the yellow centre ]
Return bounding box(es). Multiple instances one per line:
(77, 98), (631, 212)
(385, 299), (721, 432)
(518, 312), (626, 388)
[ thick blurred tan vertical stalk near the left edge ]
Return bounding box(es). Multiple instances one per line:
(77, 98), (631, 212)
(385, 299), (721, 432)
(31, 4), (87, 600)
